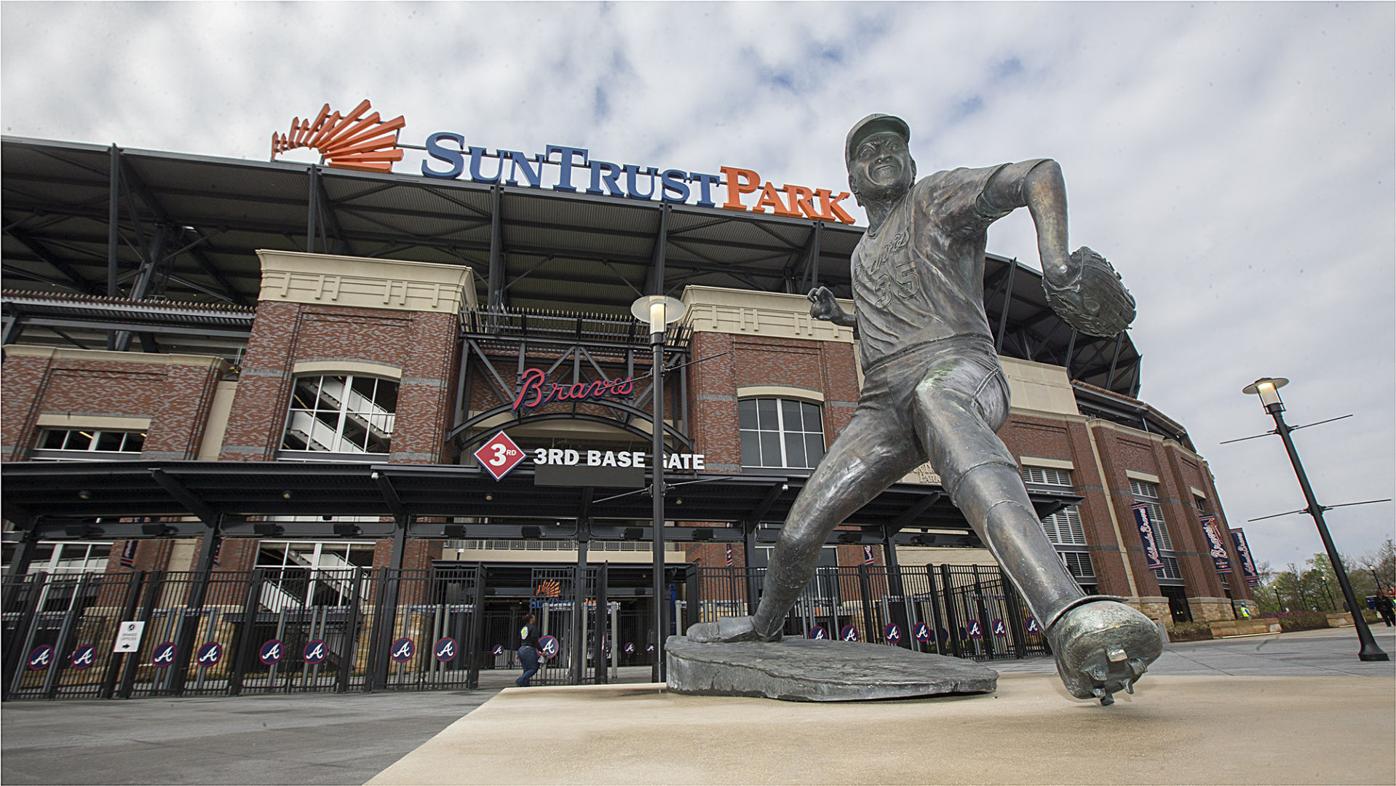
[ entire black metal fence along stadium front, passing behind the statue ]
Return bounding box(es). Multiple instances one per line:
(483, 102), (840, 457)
(0, 565), (1046, 699)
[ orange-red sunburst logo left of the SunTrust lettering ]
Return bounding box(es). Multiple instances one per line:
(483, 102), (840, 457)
(271, 99), (408, 172)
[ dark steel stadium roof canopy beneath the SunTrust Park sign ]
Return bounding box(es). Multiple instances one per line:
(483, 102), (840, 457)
(0, 137), (1141, 395)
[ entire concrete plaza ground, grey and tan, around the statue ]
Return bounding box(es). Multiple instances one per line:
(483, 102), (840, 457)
(0, 628), (1396, 783)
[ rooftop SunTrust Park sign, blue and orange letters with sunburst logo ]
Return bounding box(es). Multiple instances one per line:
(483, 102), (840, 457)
(271, 99), (854, 223)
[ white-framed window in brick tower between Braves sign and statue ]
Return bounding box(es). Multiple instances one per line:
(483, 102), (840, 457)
(737, 398), (824, 469)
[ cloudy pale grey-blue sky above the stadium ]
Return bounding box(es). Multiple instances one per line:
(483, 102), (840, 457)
(0, 3), (1396, 564)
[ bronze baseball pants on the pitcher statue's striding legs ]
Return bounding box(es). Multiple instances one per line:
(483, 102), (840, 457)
(754, 336), (1085, 638)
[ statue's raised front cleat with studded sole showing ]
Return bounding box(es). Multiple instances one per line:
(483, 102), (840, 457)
(1047, 600), (1163, 706)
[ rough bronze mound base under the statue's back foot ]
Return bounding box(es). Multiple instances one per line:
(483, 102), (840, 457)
(664, 635), (998, 701)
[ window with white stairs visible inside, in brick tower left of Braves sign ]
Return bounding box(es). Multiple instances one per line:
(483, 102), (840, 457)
(281, 376), (398, 454)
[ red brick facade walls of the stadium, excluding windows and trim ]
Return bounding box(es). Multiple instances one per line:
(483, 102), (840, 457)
(0, 266), (1249, 620)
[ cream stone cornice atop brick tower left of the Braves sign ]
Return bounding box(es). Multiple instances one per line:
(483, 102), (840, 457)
(257, 249), (476, 314)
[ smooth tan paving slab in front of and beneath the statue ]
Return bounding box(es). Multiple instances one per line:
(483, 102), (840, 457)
(369, 673), (1396, 786)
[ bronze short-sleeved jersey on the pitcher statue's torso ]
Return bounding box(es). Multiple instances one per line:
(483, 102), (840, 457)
(852, 165), (1018, 367)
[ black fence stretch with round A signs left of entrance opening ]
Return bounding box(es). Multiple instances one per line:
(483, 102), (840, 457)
(0, 565), (486, 699)
